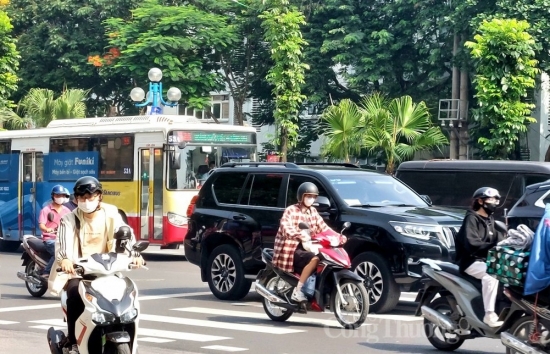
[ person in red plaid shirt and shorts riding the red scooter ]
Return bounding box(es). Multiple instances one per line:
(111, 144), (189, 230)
(273, 182), (344, 302)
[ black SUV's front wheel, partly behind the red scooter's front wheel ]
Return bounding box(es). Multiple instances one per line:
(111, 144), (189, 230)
(352, 252), (401, 313)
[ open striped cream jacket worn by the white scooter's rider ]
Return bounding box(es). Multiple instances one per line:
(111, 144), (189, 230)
(48, 202), (136, 296)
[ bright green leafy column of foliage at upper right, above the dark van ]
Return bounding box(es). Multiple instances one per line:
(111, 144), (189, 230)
(466, 19), (539, 159)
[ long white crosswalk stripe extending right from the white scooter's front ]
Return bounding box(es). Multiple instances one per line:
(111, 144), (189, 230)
(139, 314), (305, 334)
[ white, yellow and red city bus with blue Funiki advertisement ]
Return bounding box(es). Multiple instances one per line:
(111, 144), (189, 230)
(0, 115), (257, 251)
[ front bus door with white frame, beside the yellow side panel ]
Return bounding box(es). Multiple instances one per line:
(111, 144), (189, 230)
(139, 148), (163, 243)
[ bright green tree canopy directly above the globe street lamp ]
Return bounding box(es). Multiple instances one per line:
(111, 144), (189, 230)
(105, 0), (237, 108)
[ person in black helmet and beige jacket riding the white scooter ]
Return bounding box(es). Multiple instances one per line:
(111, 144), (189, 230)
(51, 176), (143, 354)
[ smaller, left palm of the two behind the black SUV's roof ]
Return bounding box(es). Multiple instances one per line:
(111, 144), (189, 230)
(321, 99), (361, 162)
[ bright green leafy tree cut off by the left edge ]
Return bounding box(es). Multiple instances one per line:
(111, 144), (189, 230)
(0, 11), (20, 109)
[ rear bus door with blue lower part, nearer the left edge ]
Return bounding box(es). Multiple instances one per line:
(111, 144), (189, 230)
(19, 151), (44, 237)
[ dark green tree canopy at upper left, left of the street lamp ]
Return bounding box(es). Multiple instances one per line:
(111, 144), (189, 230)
(6, 0), (138, 115)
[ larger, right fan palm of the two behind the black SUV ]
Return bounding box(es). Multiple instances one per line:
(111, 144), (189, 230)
(359, 93), (447, 174)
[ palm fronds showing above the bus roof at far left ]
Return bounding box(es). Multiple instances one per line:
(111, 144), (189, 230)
(0, 88), (89, 129)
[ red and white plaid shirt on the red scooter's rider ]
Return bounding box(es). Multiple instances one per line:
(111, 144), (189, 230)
(272, 204), (329, 272)
